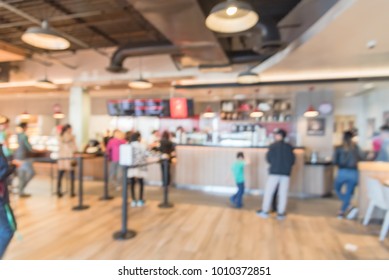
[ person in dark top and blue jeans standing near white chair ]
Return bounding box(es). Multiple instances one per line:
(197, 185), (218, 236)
(334, 131), (362, 219)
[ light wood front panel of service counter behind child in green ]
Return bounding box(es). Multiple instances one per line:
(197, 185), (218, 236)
(176, 146), (304, 192)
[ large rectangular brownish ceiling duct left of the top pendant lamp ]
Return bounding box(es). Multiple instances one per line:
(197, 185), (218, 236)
(123, 0), (229, 67)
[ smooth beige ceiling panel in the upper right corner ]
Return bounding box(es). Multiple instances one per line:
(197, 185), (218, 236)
(259, 0), (389, 80)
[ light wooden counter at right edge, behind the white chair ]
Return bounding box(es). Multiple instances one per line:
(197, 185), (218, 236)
(358, 161), (389, 219)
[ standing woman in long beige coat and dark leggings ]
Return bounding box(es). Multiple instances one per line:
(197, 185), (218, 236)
(57, 124), (77, 197)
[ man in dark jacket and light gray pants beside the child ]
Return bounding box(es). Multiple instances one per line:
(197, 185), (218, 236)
(257, 129), (295, 220)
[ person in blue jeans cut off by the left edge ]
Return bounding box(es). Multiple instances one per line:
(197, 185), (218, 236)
(0, 144), (16, 260)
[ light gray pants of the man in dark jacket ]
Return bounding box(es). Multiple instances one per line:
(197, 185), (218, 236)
(262, 174), (290, 214)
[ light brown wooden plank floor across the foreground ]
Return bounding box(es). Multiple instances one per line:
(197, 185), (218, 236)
(5, 178), (389, 259)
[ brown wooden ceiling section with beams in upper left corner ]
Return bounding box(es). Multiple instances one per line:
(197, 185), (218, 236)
(0, 0), (167, 52)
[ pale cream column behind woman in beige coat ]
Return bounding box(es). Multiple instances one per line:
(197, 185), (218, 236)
(69, 86), (91, 150)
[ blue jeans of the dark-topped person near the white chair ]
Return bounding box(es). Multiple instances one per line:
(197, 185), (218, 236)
(335, 169), (358, 213)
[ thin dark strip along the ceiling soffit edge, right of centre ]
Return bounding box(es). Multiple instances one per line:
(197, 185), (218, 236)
(174, 76), (389, 89)
